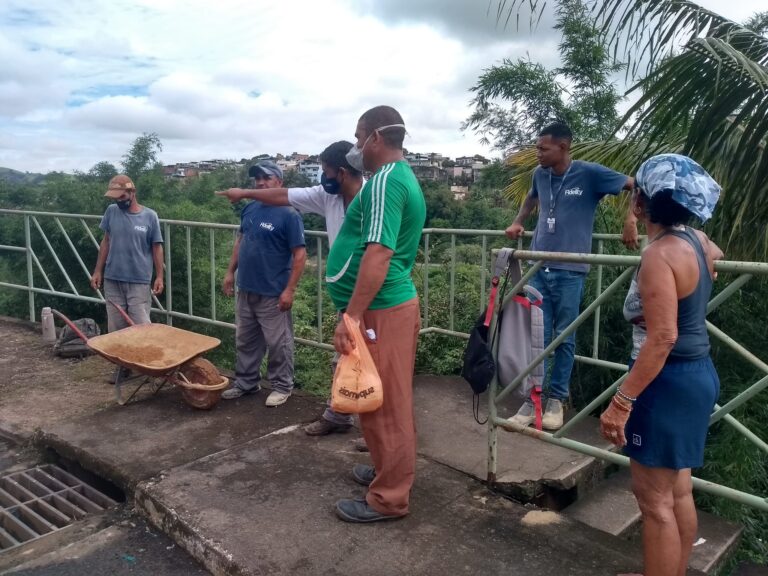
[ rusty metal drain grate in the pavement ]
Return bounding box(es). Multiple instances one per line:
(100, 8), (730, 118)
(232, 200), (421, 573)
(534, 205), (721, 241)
(0, 464), (117, 553)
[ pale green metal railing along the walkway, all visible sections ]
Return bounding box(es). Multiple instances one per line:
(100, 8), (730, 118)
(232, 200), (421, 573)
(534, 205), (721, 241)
(0, 209), (768, 510)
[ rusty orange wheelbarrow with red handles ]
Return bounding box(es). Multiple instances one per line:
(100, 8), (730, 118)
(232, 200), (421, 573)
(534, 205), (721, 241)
(52, 300), (229, 410)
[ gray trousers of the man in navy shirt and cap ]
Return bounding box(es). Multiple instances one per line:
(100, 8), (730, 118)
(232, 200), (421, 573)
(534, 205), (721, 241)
(235, 290), (293, 394)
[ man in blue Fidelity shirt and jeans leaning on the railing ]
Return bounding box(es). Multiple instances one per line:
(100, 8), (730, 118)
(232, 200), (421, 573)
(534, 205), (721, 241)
(506, 122), (637, 430)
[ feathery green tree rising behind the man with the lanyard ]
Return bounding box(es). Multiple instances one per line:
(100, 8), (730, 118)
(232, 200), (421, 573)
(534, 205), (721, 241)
(462, 0), (622, 150)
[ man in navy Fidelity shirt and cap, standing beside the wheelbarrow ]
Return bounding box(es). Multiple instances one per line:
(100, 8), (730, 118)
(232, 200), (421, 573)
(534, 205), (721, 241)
(222, 161), (307, 406)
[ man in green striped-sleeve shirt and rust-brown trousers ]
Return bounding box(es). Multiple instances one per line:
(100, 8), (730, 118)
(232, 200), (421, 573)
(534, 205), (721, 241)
(326, 106), (426, 522)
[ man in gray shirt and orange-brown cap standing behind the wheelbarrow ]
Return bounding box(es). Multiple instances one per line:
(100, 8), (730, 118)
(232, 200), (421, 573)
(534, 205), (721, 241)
(91, 174), (164, 376)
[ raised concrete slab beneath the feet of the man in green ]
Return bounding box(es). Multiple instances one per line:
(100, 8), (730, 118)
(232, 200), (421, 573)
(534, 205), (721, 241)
(136, 430), (639, 576)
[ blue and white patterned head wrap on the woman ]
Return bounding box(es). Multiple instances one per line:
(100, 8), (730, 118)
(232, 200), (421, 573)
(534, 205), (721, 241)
(635, 154), (720, 222)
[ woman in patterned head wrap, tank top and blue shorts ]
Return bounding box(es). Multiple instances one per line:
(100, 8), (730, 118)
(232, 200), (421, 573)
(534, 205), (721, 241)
(600, 154), (723, 576)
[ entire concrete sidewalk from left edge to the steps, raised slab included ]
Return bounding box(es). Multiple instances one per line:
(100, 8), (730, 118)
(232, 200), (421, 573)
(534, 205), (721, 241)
(0, 320), (704, 576)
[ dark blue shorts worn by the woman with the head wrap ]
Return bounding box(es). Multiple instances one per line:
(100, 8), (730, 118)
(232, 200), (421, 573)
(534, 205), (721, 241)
(624, 357), (720, 470)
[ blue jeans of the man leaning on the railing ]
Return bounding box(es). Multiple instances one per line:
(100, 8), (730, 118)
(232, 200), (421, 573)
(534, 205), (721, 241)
(531, 267), (587, 401)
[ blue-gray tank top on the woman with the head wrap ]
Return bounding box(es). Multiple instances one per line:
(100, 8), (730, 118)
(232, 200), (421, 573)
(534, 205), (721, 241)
(624, 226), (712, 360)
